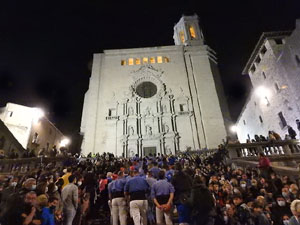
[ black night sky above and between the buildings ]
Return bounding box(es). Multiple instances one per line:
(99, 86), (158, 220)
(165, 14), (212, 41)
(0, 0), (300, 135)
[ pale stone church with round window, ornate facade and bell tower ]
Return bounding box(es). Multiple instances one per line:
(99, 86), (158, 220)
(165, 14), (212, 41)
(81, 15), (230, 157)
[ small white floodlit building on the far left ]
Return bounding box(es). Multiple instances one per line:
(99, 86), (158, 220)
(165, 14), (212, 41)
(0, 103), (66, 152)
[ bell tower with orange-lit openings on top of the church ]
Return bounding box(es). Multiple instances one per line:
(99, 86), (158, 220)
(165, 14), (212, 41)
(173, 14), (204, 46)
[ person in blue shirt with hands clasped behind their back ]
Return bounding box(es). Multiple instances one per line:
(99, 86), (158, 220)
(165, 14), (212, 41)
(151, 170), (175, 225)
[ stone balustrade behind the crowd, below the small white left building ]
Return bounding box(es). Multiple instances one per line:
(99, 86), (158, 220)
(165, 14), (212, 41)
(0, 157), (68, 173)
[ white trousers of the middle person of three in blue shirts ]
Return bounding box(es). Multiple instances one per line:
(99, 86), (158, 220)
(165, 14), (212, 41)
(130, 200), (148, 225)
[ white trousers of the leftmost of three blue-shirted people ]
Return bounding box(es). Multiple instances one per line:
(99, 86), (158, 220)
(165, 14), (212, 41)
(111, 197), (127, 225)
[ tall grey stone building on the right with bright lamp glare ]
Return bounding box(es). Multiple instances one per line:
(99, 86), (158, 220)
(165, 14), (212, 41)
(236, 20), (300, 142)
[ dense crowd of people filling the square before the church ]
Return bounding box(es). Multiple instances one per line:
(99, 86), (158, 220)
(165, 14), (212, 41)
(0, 146), (300, 225)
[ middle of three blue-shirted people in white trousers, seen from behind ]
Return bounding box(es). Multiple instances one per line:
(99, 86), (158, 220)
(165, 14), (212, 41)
(125, 170), (150, 225)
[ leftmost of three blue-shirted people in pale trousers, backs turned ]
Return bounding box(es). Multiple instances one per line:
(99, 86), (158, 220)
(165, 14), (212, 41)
(108, 171), (127, 225)
